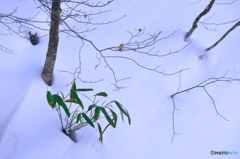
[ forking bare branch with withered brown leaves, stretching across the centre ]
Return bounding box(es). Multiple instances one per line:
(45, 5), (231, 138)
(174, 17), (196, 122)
(57, 14), (189, 90)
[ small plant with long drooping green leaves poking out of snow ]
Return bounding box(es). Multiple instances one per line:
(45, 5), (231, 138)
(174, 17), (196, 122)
(47, 81), (131, 142)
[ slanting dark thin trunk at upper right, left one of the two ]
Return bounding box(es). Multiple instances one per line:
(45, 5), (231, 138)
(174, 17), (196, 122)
(184, 0), (215, 40)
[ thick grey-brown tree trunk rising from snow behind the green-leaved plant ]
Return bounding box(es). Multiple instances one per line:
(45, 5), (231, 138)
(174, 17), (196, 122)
(42, 0), (61, 86)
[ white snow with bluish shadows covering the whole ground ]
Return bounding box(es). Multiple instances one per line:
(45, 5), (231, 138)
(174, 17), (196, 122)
(0, 0), (240, 159)
